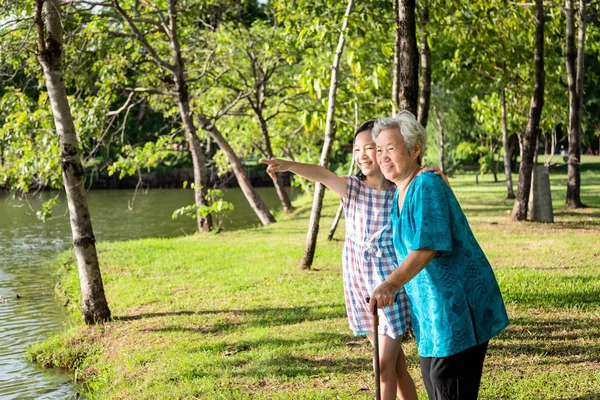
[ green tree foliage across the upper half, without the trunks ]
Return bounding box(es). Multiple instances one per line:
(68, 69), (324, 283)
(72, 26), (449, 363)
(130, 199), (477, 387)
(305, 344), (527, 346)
(0, 0), (600, 200)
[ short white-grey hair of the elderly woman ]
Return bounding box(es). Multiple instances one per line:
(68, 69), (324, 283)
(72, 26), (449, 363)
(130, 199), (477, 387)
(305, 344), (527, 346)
(371, 110), (427, 165)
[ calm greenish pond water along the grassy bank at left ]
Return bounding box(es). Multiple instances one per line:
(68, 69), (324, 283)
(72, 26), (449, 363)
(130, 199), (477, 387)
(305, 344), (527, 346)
(0, 188), (296, 400)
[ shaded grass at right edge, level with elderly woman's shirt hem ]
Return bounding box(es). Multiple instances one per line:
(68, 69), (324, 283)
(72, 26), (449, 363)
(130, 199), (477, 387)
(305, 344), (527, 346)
(490, 318), (600, 366)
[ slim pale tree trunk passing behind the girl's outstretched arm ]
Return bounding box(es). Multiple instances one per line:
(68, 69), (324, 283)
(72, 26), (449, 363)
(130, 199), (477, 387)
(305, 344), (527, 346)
(300, 0), (354, 269)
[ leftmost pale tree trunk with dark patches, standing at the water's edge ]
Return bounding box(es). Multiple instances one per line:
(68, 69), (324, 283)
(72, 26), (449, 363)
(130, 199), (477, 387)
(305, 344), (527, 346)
(35, 0), (110, 324)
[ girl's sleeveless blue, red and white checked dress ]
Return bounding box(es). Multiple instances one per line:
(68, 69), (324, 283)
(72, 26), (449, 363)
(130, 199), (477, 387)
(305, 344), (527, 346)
(342, 176), (410, 338)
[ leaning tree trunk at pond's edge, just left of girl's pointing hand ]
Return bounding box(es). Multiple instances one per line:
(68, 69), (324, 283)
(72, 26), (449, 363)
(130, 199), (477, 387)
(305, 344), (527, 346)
(198, 114), (275, 225)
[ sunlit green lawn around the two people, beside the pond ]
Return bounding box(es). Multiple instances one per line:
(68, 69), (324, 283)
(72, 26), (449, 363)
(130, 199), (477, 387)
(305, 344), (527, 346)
(30, 157), (600, 400)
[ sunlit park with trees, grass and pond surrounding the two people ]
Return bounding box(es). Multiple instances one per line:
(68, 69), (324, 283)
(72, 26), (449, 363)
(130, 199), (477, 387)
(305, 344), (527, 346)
(0, 0), (600, 399)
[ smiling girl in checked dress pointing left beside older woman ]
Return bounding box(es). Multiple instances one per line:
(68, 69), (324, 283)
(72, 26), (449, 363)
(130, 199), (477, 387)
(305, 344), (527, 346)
(260, 121), (417, 400)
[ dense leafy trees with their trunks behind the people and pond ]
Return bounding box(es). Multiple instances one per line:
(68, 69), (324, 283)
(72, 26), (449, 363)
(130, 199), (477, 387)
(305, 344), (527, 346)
(0, 0), (600, 276)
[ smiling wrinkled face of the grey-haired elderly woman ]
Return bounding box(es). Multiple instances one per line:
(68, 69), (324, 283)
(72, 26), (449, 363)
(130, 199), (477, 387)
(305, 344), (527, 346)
(375, 129), (420, 182)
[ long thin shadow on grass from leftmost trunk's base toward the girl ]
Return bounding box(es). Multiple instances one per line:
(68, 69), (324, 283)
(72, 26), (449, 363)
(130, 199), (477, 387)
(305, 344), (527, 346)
(114, 304), (346, 333)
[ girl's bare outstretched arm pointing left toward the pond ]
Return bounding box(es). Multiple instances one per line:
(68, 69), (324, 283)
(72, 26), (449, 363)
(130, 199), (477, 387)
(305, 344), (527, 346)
(259, 158), (347, 196)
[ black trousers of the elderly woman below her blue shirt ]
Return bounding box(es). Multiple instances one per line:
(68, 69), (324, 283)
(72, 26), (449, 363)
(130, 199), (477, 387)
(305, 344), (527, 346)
(419, 342), (488, 400)
